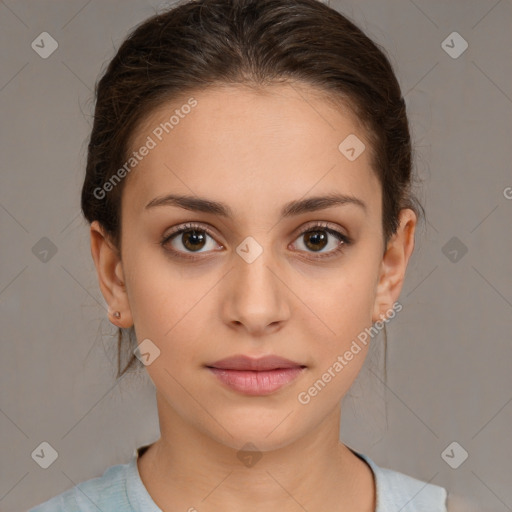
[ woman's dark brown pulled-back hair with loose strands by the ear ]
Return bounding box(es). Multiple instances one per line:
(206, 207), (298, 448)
(81, 0), (423, 378)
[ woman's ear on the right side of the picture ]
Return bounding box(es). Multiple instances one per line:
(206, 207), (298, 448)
(372, 208), (417, 322)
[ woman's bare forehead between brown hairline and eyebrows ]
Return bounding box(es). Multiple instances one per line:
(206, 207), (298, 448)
(123, 83), (380, 220)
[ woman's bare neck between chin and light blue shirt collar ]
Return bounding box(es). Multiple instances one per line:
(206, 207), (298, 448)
(138, 395), (375, 512)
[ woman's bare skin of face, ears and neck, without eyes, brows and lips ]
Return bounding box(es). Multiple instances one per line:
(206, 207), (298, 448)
(91, 84), (416, 512)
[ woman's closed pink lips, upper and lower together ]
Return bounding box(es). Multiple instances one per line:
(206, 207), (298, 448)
(207, 355), (305, 395)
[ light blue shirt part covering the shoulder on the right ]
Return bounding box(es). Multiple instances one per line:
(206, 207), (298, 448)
(356, 454), (448, 512)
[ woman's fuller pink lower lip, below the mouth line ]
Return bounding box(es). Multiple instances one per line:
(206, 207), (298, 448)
(208, 367), (304, 396)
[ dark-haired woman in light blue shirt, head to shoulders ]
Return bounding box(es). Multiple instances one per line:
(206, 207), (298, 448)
(27, 0), (464, 512)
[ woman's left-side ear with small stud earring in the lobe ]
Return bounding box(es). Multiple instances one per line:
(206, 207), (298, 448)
(91, 221), (133, 328)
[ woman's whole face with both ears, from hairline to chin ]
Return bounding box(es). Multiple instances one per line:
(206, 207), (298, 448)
(92, 84), (414, 450)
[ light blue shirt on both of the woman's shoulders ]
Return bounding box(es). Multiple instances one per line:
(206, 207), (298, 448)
(28, 445), (447, 512)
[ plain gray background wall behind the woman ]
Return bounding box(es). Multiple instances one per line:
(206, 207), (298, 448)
(0, 0), (512, 512)
